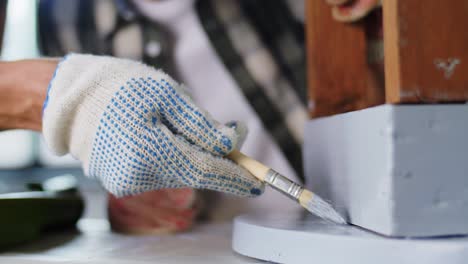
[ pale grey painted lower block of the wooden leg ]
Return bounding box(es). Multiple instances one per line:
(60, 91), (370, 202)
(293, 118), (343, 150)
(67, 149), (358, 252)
(304, 105), (468, 236)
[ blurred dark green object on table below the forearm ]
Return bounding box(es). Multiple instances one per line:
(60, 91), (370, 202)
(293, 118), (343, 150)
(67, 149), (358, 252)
(0, 175), (84, 249)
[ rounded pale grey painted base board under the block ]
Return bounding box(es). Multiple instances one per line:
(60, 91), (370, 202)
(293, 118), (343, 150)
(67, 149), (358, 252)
(232, 213), (468, 264)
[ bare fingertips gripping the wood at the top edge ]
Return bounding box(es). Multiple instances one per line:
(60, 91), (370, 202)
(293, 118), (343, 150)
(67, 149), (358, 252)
(325, 0), (382, 22)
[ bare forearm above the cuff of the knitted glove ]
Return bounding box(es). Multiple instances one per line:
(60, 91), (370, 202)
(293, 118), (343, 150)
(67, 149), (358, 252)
(0, 60), (57, 131)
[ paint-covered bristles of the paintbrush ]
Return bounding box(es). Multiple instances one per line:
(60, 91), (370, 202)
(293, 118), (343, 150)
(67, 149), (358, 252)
(299, 190), (346, 224)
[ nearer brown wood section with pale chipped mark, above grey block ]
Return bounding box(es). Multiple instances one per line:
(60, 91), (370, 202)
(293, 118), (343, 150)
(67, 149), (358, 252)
(383, 0), (468, 103)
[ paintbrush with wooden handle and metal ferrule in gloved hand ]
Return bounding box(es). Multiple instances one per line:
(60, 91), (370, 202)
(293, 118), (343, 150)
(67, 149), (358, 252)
(227, 150), (346, 224)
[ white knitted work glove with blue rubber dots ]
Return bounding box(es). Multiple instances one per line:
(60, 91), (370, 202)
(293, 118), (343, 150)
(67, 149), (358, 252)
(43, 54), (263, 196)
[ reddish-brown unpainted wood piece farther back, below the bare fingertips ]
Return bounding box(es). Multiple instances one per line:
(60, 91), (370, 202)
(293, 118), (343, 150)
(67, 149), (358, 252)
(306, 0), (385, 117)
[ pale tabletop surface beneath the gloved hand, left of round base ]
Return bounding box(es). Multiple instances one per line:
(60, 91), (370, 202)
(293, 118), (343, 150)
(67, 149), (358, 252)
(0, 219), (259, 264)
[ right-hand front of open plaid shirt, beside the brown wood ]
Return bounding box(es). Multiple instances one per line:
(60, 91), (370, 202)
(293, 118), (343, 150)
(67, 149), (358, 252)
(196, 0), (307, 179)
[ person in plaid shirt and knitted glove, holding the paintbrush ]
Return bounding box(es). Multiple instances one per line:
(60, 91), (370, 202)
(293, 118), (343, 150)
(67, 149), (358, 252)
(0, 0), (379, 233)
